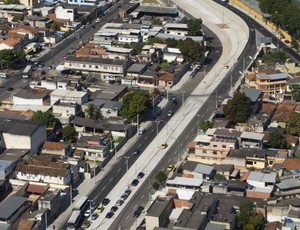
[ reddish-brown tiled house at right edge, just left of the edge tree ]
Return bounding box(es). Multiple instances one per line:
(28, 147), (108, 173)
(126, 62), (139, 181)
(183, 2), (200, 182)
(270, 103), (295, 128)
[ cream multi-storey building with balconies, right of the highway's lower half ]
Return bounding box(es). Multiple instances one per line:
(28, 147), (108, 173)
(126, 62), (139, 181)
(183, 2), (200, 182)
(187, 134), (238, 164)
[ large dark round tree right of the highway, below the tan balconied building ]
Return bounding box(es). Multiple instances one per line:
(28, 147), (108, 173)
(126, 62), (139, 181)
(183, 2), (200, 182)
(223, 91), (251, 123)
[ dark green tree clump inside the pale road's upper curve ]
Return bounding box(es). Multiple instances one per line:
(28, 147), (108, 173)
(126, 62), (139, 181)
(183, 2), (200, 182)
(178, 38), (204, 61)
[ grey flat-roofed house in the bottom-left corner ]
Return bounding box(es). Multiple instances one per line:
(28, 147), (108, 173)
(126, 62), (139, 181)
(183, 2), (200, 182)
(0, 196), (28, 225)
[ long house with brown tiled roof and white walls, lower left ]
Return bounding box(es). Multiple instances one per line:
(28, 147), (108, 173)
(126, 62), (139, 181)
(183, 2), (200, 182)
(15, 155), (71, 185)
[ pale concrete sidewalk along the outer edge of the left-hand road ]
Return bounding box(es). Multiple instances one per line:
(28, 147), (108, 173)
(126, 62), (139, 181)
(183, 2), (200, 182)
(47, 99), (167, 230)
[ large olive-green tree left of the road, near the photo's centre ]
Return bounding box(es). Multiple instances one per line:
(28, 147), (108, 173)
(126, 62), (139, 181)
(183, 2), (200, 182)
(120, 91), (150, 121)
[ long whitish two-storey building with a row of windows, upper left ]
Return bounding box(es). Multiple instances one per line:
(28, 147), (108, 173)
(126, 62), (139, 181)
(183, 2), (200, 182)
(64, 56), (129, 80)
